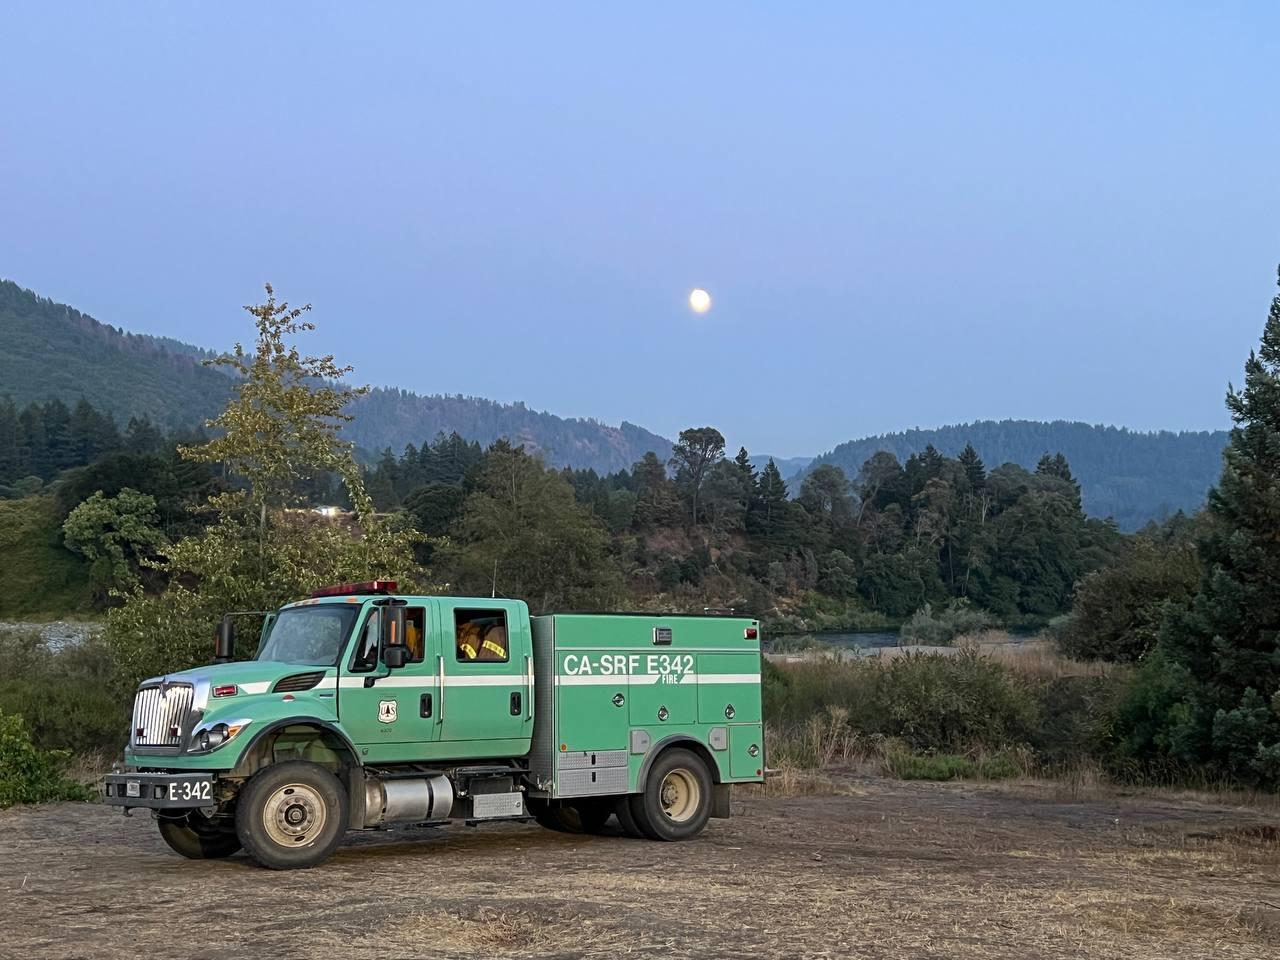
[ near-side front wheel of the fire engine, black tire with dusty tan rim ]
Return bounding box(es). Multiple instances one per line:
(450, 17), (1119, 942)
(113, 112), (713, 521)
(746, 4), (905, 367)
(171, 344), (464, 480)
(236, 760), (348, 870)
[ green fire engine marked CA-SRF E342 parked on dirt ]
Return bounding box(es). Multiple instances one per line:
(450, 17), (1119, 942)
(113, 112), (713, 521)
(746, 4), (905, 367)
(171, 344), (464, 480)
(104, 581), (764, 869)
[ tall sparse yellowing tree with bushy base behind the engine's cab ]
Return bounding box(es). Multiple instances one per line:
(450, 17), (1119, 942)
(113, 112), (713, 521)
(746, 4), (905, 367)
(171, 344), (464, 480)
(105, 287), (421, 687)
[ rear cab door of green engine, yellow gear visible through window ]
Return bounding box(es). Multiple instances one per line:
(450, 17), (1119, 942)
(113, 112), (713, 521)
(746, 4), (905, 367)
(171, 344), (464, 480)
(436, 598), (534, 758)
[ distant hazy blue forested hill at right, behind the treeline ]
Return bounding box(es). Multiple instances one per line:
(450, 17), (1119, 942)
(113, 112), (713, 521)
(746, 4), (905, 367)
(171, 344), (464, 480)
(791, 420), (1226, 530)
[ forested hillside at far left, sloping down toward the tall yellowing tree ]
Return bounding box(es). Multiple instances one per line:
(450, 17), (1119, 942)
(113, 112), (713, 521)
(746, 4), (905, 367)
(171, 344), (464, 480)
(0, 280), (230, 430)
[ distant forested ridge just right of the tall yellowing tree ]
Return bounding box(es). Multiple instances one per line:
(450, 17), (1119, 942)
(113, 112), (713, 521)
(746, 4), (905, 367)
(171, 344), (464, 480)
(347, 389), (671, 474)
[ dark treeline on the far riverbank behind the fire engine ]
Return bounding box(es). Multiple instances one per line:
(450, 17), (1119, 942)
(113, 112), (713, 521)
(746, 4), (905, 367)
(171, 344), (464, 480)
(366, 428), (1124, 628)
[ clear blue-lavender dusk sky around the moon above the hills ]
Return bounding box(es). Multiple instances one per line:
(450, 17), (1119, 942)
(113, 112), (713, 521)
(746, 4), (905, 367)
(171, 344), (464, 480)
(0, 0), (1280, 456)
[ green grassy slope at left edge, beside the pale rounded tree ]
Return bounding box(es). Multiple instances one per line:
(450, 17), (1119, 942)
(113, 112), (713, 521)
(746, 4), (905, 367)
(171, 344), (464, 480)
(0, 497), (92, 617)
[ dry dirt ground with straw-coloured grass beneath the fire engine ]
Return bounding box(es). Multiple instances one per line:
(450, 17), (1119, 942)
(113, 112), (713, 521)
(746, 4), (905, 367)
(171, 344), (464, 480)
(0, 780), (1280, 960)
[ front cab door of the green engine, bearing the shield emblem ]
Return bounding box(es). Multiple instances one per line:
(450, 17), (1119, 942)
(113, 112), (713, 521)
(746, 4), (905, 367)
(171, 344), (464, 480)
(338, 600), (440, 760)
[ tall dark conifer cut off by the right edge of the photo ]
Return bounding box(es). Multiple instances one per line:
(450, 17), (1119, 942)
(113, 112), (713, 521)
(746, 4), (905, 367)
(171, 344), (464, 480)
(1128, 271), (1280, 785)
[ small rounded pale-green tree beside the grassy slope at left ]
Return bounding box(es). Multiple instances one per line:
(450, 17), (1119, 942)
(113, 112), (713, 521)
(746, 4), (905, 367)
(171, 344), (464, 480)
(63, 486), (166, 596)
